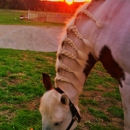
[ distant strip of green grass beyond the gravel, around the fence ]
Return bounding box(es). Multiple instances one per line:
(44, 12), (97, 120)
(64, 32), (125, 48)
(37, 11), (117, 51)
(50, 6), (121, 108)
(0, 10), (63, 26)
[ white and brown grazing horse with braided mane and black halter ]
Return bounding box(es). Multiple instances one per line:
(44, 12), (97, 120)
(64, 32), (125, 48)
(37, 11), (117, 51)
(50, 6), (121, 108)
(40, 0), (130, 130)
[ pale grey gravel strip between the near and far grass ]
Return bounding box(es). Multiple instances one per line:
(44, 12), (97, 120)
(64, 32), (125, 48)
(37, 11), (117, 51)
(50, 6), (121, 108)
(0, 25), (63, 52)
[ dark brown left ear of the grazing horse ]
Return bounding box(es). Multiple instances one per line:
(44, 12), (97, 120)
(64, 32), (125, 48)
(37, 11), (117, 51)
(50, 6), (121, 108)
(42, 73), (52, 91)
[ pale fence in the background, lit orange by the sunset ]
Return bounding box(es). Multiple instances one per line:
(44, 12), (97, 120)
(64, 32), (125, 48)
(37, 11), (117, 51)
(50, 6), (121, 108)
(28, 10), (72, 23)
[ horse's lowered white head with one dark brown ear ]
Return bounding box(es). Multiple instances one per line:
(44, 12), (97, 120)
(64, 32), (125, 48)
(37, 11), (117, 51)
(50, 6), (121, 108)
(40, 74), (78, 130)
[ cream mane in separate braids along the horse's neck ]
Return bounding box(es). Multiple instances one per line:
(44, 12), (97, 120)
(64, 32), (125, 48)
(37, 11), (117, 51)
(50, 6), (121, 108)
(55, 3), (100, 91)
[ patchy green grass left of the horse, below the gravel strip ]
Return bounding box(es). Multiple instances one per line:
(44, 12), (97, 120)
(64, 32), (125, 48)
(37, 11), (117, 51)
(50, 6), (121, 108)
(0, 49), (56, 130)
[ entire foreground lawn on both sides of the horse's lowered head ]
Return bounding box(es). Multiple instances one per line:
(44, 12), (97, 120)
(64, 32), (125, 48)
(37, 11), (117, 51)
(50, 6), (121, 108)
(0, 49), (123, 130)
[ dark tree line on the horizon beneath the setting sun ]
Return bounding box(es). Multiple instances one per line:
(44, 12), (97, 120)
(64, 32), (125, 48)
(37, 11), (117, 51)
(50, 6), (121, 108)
(0, 0), (83, 13)
